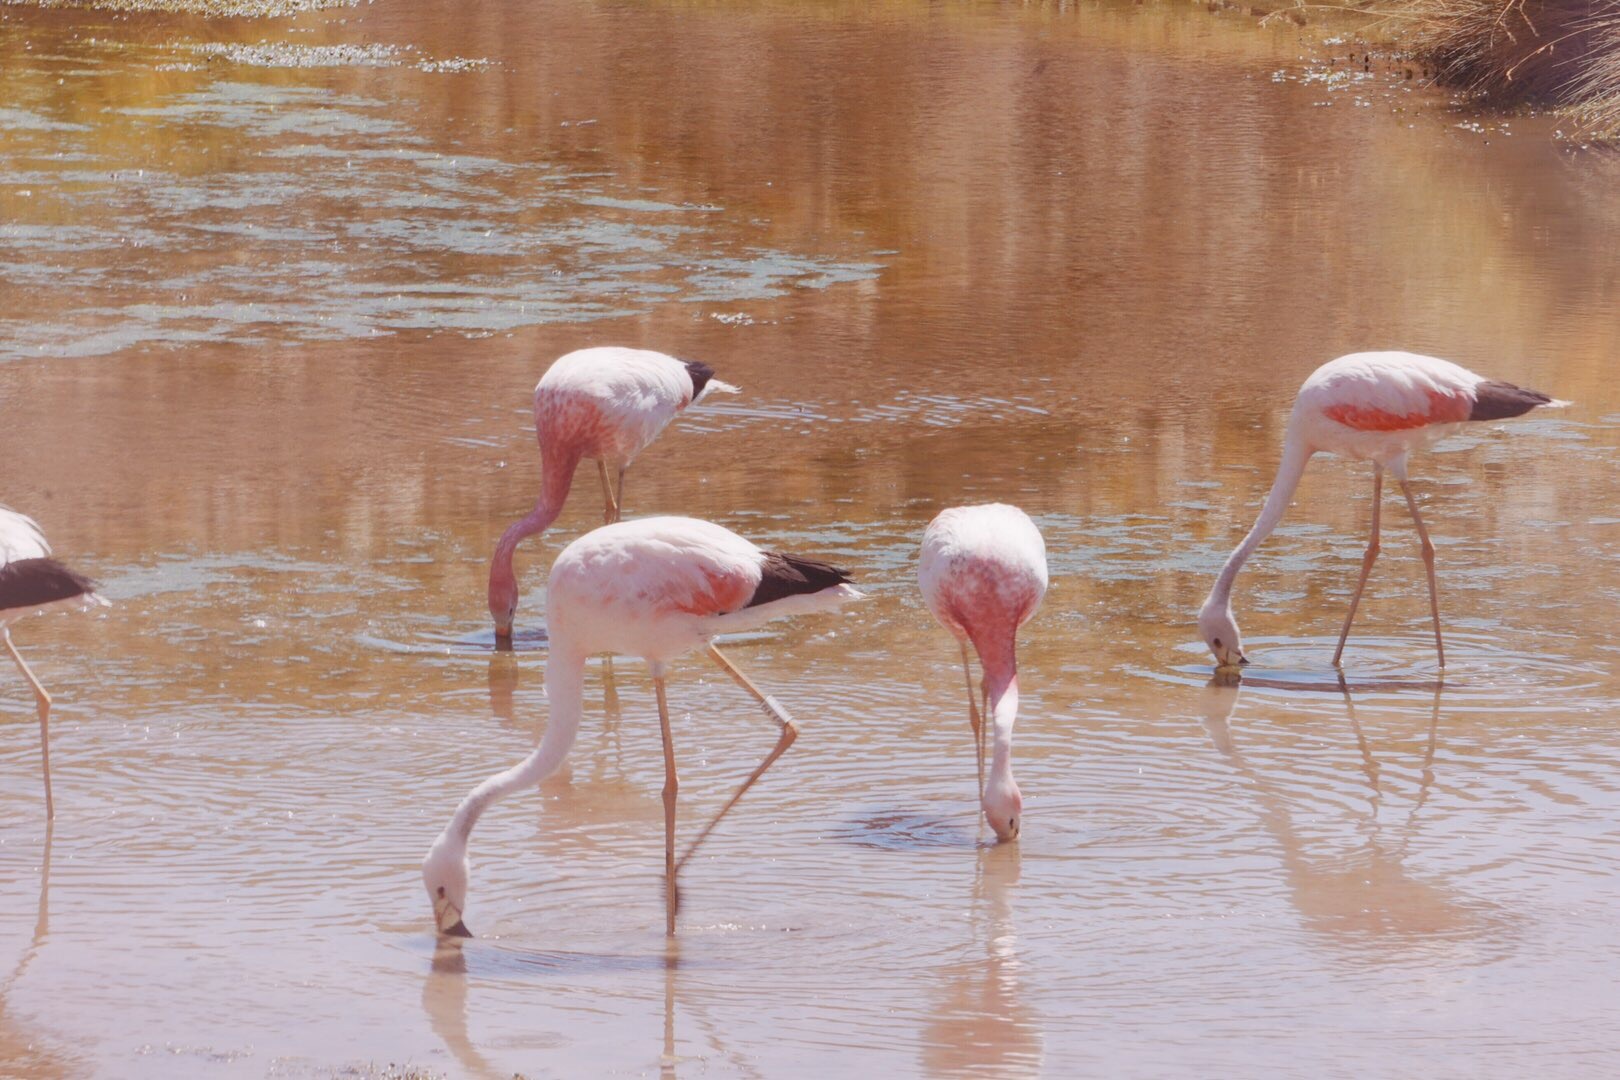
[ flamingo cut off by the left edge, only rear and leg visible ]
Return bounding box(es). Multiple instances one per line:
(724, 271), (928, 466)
(0, 507), (107, 819)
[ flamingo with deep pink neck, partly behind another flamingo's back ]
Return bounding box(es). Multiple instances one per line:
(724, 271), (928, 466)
(489, 347), (737, 643)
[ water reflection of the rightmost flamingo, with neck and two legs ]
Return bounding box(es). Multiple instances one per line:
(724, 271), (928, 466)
(1204, 677), (1495, 962)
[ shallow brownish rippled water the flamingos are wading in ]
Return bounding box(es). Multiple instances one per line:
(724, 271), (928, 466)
(0, 0), (1620, 1077)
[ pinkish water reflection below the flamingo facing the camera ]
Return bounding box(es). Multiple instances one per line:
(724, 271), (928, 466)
(922, 844), (1042, 1077)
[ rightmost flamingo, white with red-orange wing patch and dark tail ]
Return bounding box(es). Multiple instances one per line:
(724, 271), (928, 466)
(1199, 351), (1568, 669)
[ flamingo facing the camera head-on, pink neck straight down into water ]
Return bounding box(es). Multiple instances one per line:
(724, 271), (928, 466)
(917, 504), (1047, 840)
